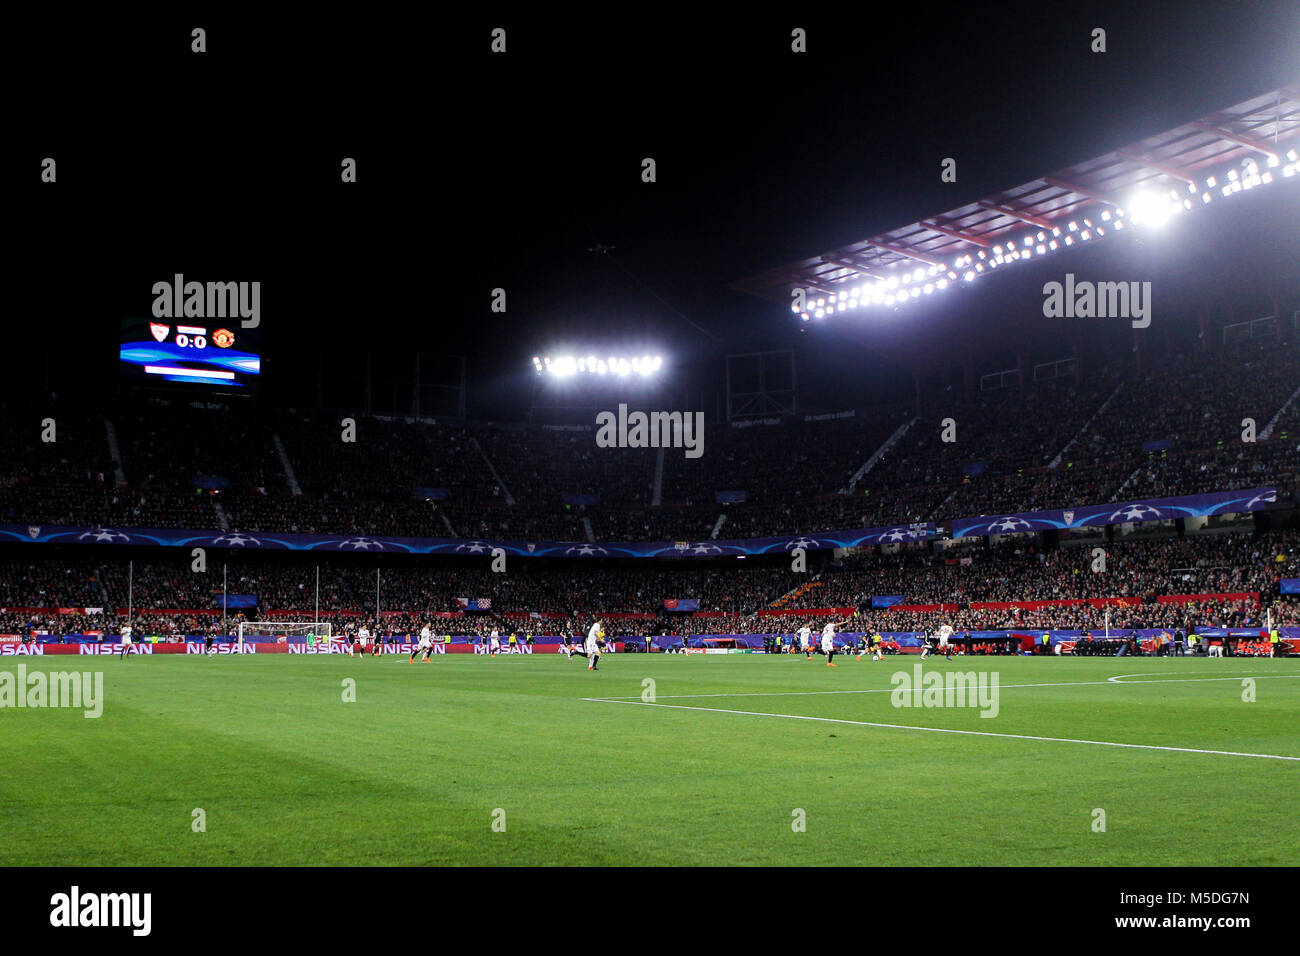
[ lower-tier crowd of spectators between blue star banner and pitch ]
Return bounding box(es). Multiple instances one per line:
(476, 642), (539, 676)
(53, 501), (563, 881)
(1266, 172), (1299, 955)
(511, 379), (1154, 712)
(0, 532), (1300, 635)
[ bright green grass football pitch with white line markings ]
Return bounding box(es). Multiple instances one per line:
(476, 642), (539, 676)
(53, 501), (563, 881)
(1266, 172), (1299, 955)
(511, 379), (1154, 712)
(0, 653), (1300, 866)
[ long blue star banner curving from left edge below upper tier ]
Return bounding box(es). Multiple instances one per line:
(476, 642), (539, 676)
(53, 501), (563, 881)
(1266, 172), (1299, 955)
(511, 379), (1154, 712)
(0, 522), (935, 558)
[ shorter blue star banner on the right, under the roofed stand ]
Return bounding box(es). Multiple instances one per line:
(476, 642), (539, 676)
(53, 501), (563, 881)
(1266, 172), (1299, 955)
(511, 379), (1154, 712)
(953, 488), (1277, 537)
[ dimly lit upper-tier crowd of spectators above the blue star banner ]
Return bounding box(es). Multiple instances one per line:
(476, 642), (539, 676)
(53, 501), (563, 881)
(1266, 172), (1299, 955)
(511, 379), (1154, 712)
(0, 342), (1300, 541)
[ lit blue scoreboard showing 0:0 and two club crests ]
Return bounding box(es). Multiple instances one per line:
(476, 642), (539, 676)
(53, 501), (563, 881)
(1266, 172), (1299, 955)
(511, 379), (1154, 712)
(118, 319), (261, 389)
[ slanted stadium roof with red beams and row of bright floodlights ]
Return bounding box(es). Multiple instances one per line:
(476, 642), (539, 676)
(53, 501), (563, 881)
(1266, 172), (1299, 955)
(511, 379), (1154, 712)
(732, 82), (1300, 321)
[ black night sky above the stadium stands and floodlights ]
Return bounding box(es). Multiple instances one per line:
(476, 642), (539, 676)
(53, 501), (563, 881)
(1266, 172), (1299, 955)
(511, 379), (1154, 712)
(5, 1), (1300, 418)
